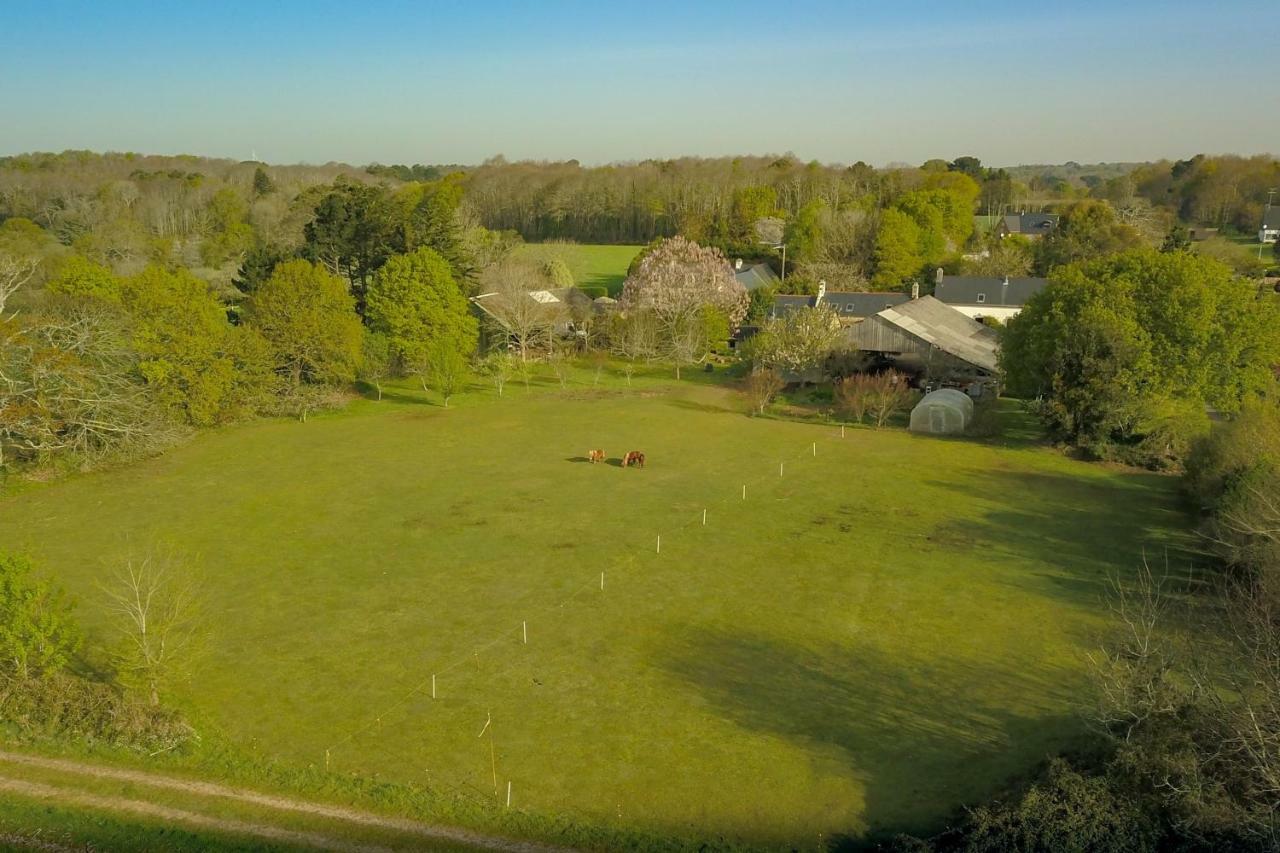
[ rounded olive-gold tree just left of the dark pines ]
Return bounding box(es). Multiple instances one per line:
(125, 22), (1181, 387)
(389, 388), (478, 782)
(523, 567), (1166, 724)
(246, 260), (361, 386)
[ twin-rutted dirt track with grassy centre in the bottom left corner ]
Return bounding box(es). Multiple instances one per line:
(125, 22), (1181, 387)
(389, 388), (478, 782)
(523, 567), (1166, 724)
(0, 751), (568, 853)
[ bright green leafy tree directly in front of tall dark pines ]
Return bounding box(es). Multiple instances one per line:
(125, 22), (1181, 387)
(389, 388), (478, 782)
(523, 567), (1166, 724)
(366, 242), (480, 369)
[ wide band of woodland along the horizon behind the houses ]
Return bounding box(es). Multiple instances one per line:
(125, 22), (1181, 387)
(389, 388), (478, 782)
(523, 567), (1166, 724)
(0, 151), (1280, 302)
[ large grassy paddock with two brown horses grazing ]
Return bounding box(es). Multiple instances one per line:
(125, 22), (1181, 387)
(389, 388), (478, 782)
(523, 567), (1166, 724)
(0, 373), (1184, 847)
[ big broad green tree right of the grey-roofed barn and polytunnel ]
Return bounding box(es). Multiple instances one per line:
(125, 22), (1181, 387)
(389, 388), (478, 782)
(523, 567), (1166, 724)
(1001, 250), (1280, 458)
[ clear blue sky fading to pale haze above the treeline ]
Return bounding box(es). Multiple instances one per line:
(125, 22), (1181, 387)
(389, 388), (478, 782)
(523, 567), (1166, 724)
(0, 0), (1280, 165)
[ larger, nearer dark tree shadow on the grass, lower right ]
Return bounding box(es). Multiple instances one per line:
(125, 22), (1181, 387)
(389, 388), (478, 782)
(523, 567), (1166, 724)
(660, 628), (1083, 849)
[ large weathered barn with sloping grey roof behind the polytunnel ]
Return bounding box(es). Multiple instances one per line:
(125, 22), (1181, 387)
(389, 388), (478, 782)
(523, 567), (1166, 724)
(846, 296), (1000, 382)
